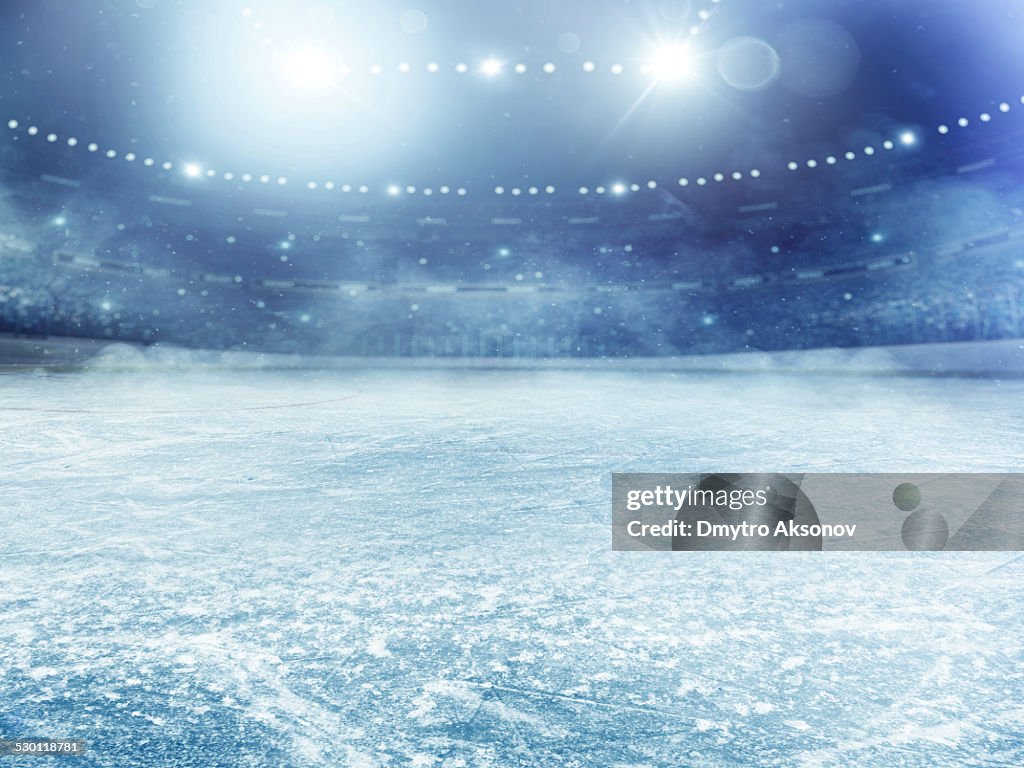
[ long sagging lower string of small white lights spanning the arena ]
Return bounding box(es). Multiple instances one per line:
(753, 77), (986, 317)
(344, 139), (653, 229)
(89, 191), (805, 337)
(7, 96), (1024, 199)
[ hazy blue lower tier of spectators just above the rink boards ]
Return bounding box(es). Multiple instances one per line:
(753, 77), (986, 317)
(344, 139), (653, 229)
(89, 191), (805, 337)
(0, 236), (1024, 357)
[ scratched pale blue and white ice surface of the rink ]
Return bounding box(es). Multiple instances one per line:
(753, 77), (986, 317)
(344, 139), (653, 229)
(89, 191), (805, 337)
(0, 370), (1024, 768)
